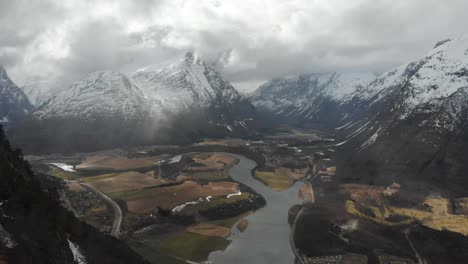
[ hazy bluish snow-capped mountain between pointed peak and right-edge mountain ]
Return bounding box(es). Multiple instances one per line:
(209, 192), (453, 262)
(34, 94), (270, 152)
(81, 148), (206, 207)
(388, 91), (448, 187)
(250, 72), (376, 126)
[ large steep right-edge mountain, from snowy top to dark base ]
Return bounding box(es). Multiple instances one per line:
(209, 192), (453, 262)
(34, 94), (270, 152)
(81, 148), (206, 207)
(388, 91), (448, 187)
(336, 37), (468, 195)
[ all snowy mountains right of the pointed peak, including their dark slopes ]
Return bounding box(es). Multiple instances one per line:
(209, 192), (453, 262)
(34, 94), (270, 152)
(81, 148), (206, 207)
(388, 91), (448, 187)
(250, 37), (468, 193)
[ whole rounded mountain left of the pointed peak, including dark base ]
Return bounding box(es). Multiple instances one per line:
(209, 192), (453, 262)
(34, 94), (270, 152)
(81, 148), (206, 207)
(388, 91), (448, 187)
(9, 71), (165, 153)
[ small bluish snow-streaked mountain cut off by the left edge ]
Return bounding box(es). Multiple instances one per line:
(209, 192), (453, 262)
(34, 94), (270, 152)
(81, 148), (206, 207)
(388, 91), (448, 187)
(0, 66), (33, 124)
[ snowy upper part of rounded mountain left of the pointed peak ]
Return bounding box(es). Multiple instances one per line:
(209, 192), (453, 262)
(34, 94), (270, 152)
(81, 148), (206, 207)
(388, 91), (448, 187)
(34, 71), (155, 120)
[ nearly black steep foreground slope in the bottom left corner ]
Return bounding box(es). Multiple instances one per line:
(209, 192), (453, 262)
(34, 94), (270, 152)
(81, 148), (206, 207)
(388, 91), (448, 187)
(0, 127), (145, 264)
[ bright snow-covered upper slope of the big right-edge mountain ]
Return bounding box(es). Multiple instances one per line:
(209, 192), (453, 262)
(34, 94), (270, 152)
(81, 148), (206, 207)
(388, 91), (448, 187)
(355, 36), (468, 118)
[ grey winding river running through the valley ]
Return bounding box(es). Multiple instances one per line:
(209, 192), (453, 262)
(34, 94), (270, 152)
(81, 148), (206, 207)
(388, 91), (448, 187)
(209, 153), (303, 264)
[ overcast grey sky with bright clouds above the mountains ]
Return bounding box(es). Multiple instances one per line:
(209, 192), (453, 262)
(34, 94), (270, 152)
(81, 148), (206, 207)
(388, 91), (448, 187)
(0, 0), (468, 93)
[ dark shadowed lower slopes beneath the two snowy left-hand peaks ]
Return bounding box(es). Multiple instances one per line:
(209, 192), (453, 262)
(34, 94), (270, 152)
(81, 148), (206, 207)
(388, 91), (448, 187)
(7, 104), (257, 154)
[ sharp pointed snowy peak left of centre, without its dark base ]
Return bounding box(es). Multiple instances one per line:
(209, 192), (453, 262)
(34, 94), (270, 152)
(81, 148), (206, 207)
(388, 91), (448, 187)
(132, 53), (255, 131)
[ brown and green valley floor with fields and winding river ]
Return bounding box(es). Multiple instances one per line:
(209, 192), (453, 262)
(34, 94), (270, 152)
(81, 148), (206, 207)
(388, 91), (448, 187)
(29, 127), (468, 264)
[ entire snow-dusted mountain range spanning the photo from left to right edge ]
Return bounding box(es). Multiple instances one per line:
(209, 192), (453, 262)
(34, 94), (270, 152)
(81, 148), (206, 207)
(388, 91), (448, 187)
(0, 37), (468, 195)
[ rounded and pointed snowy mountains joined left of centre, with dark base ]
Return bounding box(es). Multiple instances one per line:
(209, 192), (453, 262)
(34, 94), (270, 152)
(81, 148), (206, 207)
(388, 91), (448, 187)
(10, 53), (256, 152)
